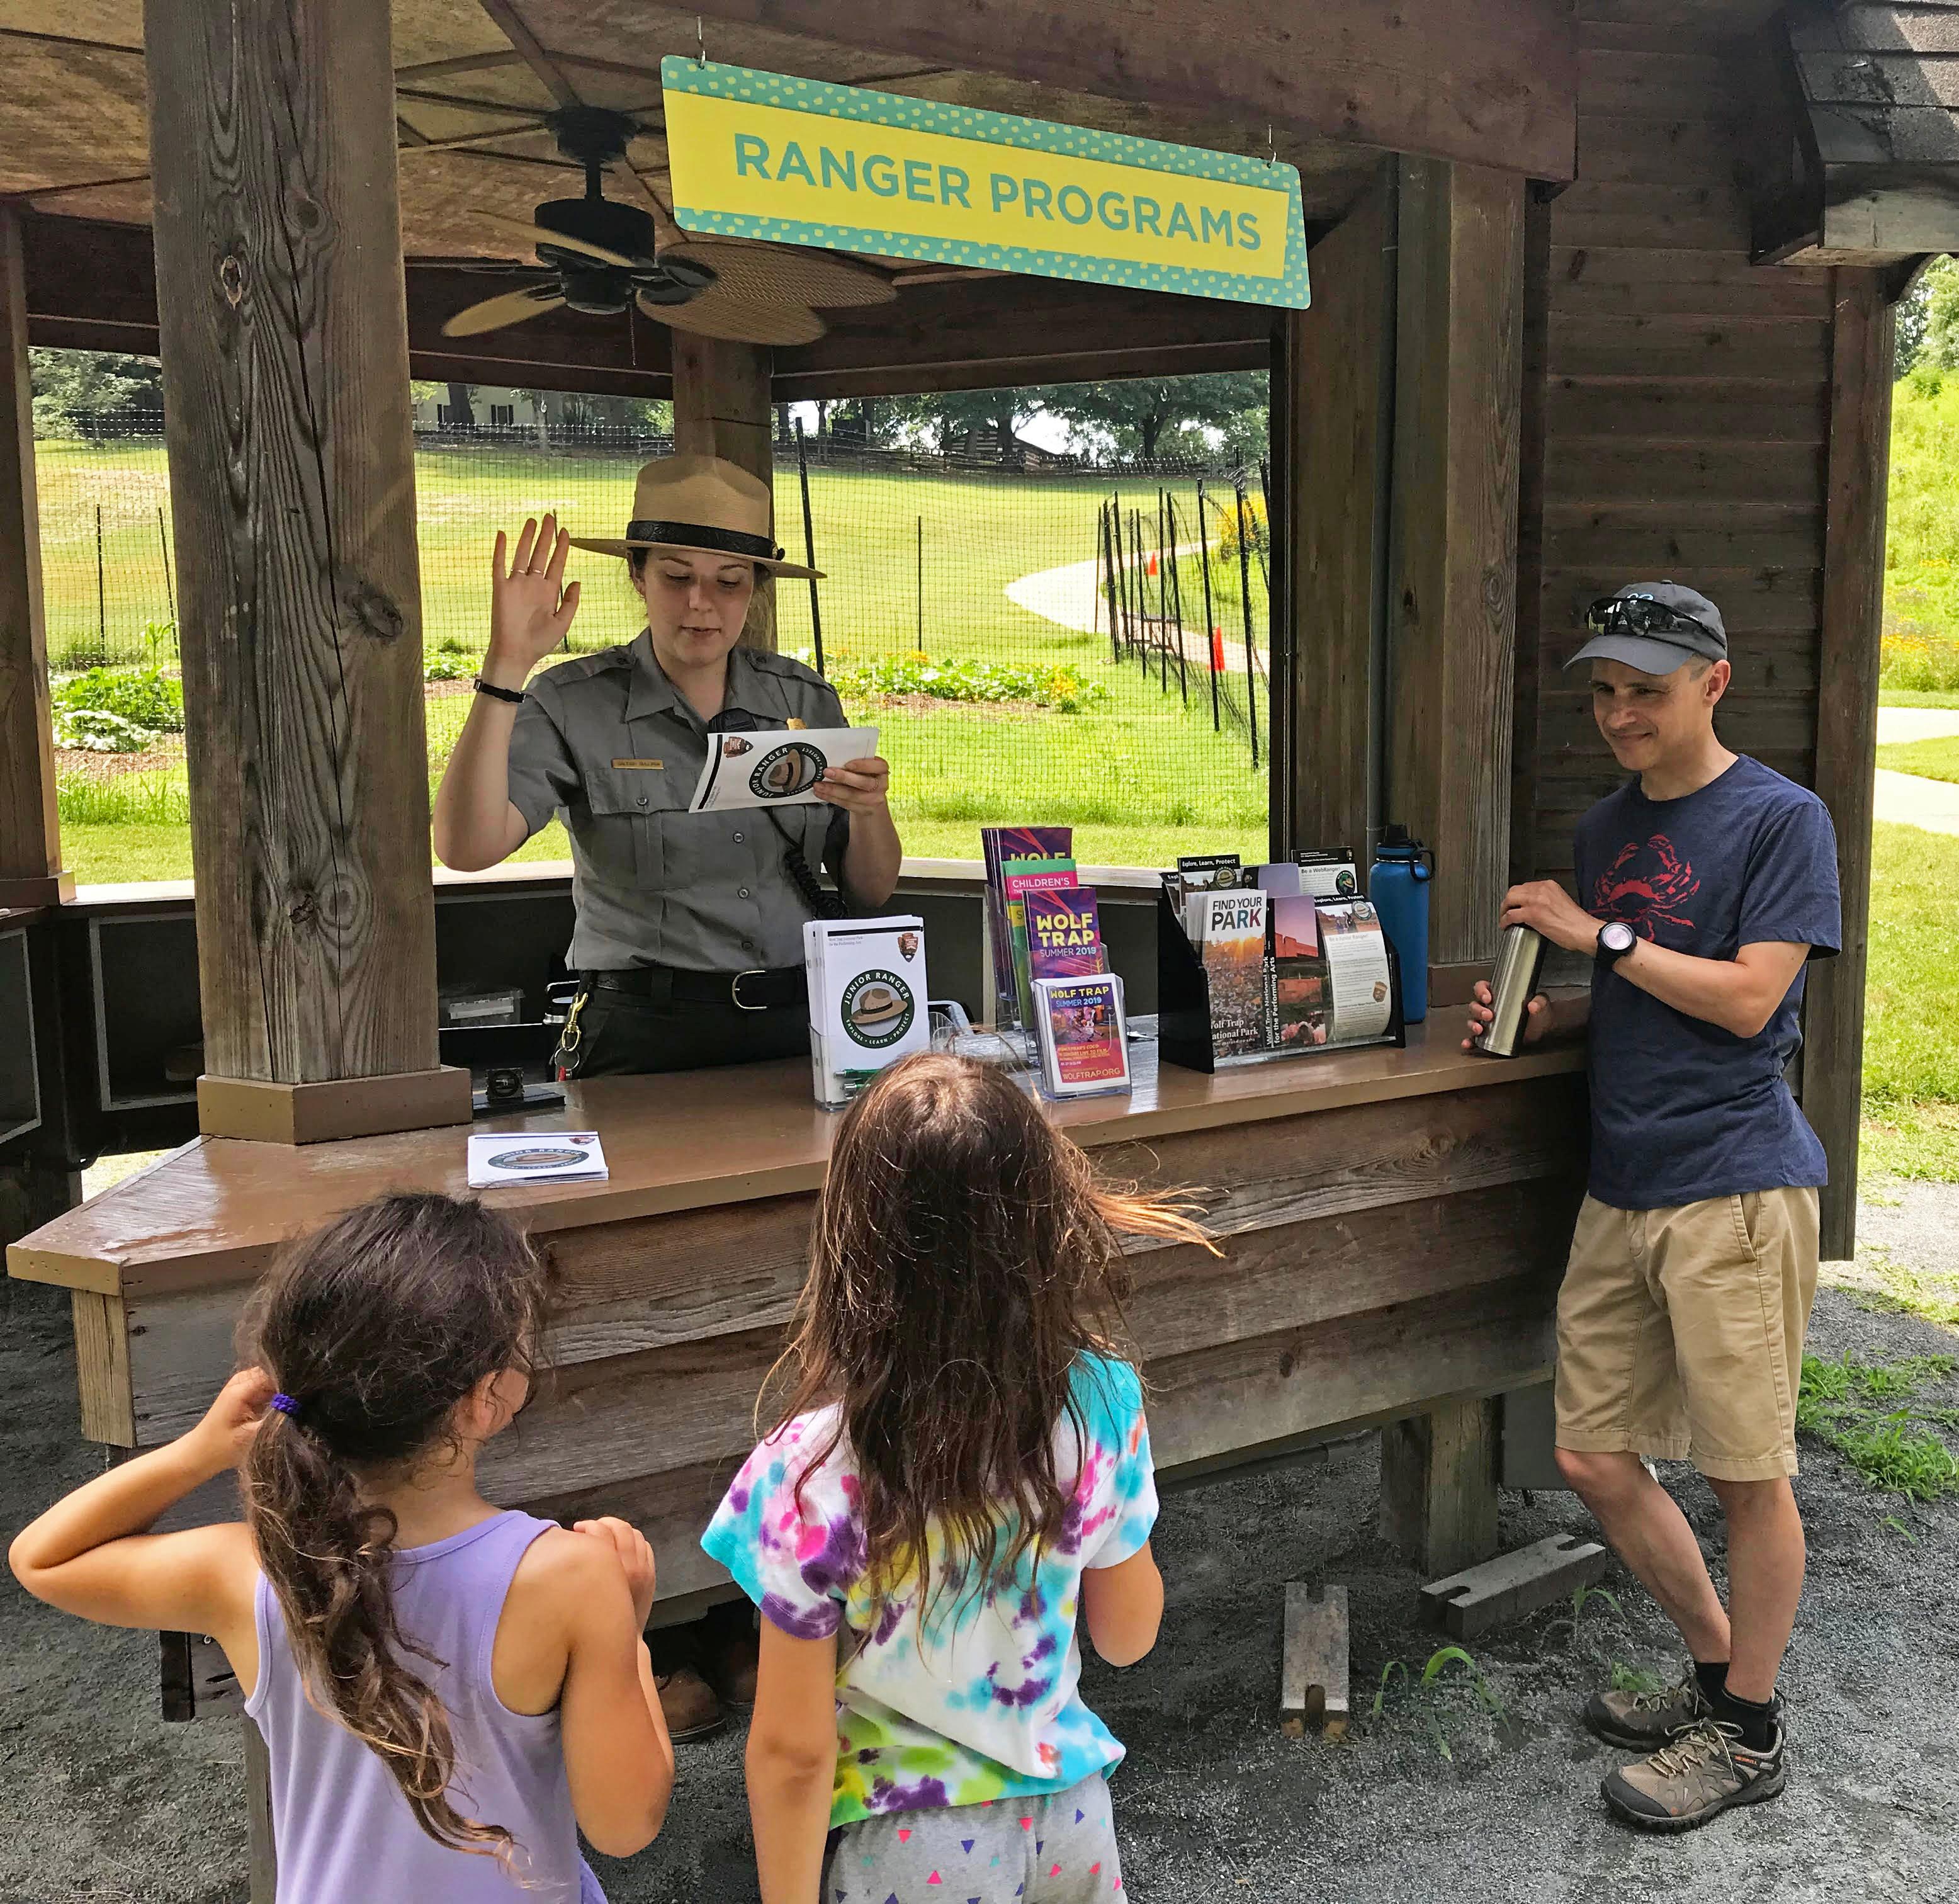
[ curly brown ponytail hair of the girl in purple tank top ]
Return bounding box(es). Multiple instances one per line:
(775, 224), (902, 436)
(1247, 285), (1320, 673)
(239, 1195), (546, 1855)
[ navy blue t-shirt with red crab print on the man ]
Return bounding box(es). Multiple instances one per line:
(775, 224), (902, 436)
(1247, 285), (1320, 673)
(1573, 754), (1841, 1211)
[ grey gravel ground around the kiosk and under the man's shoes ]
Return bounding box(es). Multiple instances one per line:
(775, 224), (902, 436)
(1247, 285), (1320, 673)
(0, 1187), (1959, 1904)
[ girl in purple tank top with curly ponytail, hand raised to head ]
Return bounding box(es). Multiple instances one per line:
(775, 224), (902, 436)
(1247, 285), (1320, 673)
(10, 1197), (674, 1904)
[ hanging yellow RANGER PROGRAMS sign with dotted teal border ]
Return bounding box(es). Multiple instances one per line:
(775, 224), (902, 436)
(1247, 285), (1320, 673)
(662, 57), (1307, 305)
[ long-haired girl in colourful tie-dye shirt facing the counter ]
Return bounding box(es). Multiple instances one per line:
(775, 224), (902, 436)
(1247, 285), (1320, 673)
(703, 1056), (1203, 1904)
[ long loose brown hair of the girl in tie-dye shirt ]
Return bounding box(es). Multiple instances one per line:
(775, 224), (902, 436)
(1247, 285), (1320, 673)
(782, 1054), (1209, 1616)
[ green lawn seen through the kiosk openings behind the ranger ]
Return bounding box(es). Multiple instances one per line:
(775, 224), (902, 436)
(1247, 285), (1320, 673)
(35, 443), (1267, 881)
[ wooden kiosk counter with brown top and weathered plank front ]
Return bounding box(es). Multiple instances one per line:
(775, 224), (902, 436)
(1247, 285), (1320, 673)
(8, 1011), (1585, 1616)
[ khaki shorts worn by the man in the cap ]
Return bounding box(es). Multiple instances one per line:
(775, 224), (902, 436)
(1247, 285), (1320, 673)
(1557, 1189), (1818, 1481)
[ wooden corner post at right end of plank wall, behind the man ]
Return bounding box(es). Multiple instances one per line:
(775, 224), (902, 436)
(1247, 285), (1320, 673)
(1802, 268), (1894, 1259)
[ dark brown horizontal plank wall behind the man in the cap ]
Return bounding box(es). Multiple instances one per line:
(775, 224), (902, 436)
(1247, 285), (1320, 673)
(1518, 0), (1832, 876)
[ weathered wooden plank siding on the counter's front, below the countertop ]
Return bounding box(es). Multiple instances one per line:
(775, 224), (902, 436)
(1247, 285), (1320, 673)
(122, 1074), (1585, 1597)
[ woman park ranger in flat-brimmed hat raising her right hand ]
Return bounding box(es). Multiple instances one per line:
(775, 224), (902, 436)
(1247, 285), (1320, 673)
(435, 456), (901, 1077)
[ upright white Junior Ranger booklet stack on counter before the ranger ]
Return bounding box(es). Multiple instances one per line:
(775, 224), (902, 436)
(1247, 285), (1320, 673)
(803, 915), (932, 1109)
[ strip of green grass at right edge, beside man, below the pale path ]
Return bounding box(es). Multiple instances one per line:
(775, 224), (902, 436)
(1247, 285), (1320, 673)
(1863, 821), (1959, 1181)
